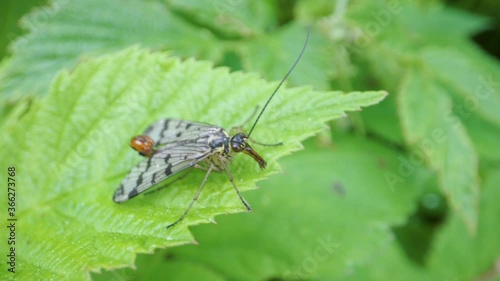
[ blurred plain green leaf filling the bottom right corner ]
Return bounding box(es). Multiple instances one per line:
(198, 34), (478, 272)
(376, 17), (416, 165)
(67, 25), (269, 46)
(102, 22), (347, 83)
(429, 168), (500, 280)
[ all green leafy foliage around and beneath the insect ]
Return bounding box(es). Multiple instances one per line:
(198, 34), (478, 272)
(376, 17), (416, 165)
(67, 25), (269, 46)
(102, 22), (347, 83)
(0, 0), (500, 280)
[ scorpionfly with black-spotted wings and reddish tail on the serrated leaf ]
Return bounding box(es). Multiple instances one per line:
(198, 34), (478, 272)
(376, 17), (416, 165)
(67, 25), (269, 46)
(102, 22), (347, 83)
(113, 31), (310, 229)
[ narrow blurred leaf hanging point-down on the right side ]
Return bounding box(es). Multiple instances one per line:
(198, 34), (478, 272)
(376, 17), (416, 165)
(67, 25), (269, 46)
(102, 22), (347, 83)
(398, 69), (479, 232)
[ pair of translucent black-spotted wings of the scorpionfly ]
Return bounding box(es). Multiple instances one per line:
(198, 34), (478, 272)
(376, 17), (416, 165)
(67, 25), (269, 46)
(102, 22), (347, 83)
(113, 119), (222, 202)
